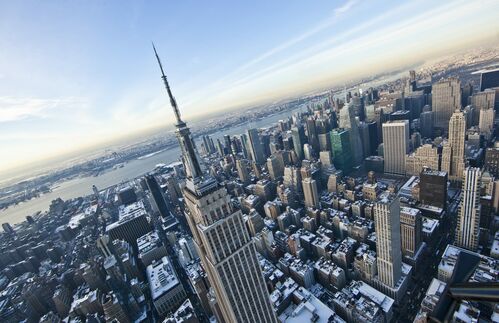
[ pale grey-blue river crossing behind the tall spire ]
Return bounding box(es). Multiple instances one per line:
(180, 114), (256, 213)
(0, 105), (306, 224)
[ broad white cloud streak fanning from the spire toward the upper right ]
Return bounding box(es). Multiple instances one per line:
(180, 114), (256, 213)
(183, 0), (497, 115)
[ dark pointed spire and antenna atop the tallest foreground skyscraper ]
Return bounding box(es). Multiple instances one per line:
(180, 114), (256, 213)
(152, 43), (203, 183)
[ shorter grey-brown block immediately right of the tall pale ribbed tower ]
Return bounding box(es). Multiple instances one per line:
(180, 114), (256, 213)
(400, 206), (421, 257)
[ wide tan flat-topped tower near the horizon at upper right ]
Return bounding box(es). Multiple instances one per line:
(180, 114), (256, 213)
(431, 77), (461, 129)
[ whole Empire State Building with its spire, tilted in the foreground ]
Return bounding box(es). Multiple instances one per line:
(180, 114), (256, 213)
(154, 45), (278, 323)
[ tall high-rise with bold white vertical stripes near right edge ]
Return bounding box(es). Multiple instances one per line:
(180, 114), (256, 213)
(456, 167), (482, 251)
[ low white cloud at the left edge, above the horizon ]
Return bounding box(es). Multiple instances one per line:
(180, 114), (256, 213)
(0, 96), (86, 123)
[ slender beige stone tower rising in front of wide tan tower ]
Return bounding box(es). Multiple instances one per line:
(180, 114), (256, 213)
(449, 111), (466, 181)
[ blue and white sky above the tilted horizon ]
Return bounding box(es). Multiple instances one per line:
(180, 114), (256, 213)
(0, 0), (499, 175)
